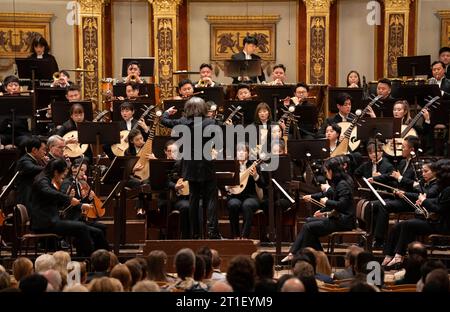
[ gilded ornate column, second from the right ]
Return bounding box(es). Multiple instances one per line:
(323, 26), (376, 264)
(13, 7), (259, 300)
(303, 0), (334, 84)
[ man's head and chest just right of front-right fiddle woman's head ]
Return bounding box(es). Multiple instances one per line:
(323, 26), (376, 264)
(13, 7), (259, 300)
(354, 140), (394, 179)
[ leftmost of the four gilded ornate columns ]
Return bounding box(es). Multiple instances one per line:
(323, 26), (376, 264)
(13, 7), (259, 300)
(76, 0), (109, 109)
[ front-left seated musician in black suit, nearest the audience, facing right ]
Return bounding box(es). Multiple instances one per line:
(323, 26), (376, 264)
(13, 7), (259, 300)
(31, 159), (109, 257)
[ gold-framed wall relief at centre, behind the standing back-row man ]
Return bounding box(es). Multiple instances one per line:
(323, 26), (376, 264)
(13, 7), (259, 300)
(206, 15), (280, 61)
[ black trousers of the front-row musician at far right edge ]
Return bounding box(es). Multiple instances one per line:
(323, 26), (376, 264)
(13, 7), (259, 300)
(383, 219), (449, 256)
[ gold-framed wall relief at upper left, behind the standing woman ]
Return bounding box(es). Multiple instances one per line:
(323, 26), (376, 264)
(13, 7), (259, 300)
(0, 13), (53, 58)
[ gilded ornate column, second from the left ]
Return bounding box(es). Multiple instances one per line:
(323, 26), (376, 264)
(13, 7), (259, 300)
(149, 0), (182, 99)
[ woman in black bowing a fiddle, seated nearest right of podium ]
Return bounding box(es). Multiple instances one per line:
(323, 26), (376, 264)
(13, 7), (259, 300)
(282, 157), (356, 262)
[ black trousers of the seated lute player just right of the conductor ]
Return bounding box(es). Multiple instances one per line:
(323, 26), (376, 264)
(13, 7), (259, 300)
(227, 197), (260, 238)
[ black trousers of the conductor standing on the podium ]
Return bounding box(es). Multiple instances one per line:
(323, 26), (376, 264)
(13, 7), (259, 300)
(189, 180), (220, 239)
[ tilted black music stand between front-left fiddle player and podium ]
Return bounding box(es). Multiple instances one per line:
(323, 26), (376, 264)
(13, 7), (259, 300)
(100, 156), (139, 255)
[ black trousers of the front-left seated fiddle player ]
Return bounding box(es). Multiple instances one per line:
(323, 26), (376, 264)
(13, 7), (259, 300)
(35, 220), (109, 257)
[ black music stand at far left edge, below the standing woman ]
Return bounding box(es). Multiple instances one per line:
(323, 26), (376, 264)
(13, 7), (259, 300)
(0, 96), (35, 146)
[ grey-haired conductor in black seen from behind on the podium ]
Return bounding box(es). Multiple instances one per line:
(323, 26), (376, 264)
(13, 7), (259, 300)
(161, 97), (221, 239)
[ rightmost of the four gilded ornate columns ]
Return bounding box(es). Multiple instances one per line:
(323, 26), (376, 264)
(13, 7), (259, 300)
(383, 0), (413, 78)
